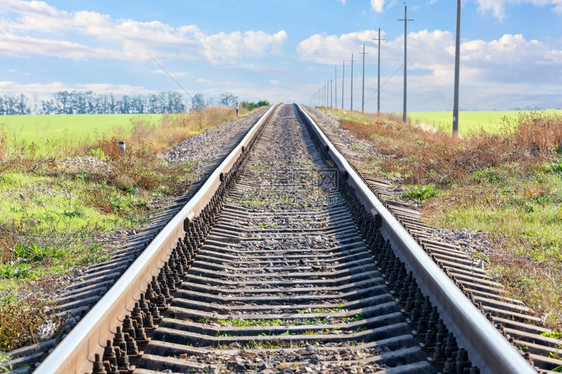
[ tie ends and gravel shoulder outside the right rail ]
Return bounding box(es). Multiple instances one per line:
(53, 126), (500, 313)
(307, 108), (562, 373)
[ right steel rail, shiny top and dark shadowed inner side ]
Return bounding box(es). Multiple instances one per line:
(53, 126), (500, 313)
(296, 105), (536, 373)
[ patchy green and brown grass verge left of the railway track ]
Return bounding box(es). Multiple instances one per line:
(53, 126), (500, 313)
(0, 104), (242, 350)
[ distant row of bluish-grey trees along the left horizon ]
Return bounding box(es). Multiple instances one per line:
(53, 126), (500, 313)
(0, 91), (269, 115)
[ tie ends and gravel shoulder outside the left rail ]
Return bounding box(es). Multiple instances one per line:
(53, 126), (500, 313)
(0, 111), (264, 373)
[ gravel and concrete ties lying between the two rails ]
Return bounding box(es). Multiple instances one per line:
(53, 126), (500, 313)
(131, 105), (427, 374)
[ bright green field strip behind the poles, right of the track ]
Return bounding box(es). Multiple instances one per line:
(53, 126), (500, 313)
(408, 109), (562, 135)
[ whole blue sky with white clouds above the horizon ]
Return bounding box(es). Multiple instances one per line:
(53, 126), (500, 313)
(0, 0), (562, 112)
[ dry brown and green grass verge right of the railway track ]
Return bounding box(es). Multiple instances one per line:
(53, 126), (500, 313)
(324, 106), (562, 331)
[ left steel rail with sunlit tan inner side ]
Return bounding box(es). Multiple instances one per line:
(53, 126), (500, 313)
(35, 106), (276, 374)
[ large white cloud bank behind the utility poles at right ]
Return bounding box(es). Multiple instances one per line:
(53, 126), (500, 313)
(298, 30), (562, 110)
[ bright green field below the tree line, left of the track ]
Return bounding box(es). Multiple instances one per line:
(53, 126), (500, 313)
(0, 114), (162, 154)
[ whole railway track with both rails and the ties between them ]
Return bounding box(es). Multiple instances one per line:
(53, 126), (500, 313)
(19, 106), (556, 374)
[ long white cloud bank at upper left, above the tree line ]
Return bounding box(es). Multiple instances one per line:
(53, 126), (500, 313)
(0, 0), (287, 64)
